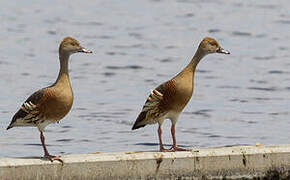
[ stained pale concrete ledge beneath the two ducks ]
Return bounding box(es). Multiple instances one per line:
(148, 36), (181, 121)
(0, 145), (290, 180)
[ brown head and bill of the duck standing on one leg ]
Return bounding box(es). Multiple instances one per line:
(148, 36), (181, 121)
(59, 37), (92, 55)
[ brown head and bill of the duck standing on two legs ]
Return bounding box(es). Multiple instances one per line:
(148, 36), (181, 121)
(199, 37), (230, 54)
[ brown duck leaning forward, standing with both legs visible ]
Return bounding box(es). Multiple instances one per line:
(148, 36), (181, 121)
(132, 37), (230, 152)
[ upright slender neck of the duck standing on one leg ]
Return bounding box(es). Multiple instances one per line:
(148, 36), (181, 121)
(54, 53), (70, 86)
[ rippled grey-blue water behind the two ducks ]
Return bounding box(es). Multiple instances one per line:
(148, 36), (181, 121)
(0, 0), (290, 157)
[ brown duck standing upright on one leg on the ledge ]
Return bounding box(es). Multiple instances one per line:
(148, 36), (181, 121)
(7, 37), (92, 163)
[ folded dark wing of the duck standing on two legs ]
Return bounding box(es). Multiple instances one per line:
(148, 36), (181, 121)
(132, 79), (176, 130)
